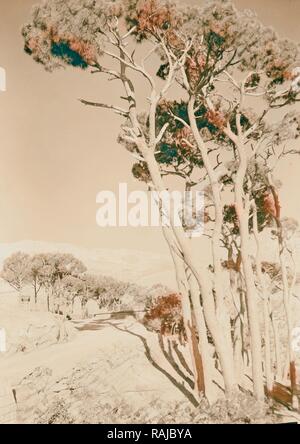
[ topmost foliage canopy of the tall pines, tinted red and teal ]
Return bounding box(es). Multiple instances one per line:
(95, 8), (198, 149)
(22, 0), (299, 83)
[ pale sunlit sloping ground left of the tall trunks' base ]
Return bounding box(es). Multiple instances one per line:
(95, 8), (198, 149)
(0, 308), (300, 424)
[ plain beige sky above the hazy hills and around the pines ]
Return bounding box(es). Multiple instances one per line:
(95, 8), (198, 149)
(0, 0), (300, 252)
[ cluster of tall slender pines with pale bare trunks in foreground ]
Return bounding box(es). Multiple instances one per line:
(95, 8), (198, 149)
(23, 0), (300, 403)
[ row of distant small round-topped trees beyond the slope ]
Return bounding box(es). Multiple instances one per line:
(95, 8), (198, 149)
(1, 252), (144, 317)
